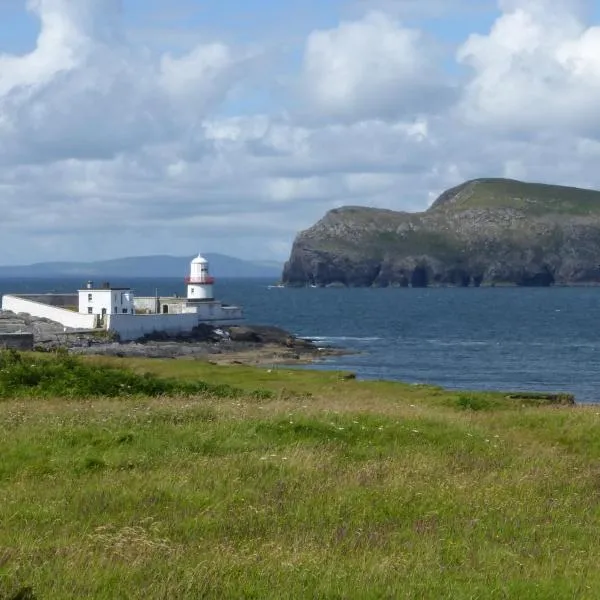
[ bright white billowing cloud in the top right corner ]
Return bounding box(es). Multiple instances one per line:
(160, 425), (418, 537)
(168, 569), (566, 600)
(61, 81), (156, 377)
(458, 0), (600, 135)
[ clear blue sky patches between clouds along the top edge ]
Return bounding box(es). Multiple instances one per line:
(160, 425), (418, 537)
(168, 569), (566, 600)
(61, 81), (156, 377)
(0, 0), (502, 53)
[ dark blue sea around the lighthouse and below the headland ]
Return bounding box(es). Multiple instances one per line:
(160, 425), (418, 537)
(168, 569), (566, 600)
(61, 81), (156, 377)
(0, 278), (600, 403)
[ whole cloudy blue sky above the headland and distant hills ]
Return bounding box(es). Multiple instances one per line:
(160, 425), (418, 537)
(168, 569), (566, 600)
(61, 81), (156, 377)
(0, 0), (600, 265)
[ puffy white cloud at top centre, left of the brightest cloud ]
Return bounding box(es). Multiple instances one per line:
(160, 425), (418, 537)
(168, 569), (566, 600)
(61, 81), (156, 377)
(303, 11), (450, 120)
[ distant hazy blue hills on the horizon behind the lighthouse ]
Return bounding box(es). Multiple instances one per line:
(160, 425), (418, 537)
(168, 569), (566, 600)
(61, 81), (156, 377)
(0, 253), (283, 279)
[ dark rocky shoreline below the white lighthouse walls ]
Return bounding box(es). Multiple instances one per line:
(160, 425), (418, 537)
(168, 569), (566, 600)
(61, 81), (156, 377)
(0, 311), (347, 365)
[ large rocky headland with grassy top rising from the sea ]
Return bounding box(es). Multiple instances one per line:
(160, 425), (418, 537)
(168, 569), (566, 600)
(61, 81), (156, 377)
(283, 179), (600, 287)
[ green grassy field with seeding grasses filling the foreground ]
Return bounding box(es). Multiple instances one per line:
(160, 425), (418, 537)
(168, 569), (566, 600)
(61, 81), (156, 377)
(0, 356), (600, 600)
